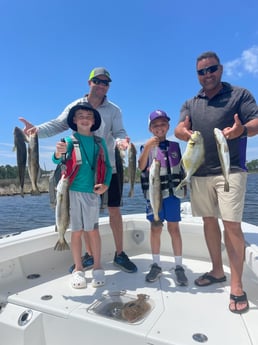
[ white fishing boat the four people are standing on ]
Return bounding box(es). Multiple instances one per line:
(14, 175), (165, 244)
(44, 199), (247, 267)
(0, 203), (258, 345)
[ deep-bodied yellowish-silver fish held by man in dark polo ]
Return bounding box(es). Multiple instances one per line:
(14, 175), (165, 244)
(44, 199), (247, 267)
(175, 131), (205, 191)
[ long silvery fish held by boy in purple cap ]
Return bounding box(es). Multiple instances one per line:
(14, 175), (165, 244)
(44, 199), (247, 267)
(149, 158), (162, 222)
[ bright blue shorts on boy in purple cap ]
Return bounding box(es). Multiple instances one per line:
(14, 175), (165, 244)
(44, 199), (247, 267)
(146, 196), (181, 222)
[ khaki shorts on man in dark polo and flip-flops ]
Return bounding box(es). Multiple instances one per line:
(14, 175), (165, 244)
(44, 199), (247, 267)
(190, 172), (247, 223)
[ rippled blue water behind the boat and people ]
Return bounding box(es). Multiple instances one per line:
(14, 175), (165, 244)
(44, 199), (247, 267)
(0, 174), (258, 234)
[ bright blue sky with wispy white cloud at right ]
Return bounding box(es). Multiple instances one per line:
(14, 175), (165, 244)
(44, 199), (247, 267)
(0, 0), (258, 169)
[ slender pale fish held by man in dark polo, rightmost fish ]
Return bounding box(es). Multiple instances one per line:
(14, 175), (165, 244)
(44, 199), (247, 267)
(214, 128), (230, 192)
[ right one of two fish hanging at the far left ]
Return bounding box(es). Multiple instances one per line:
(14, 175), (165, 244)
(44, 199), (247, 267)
(28, 133), (40, 195)
